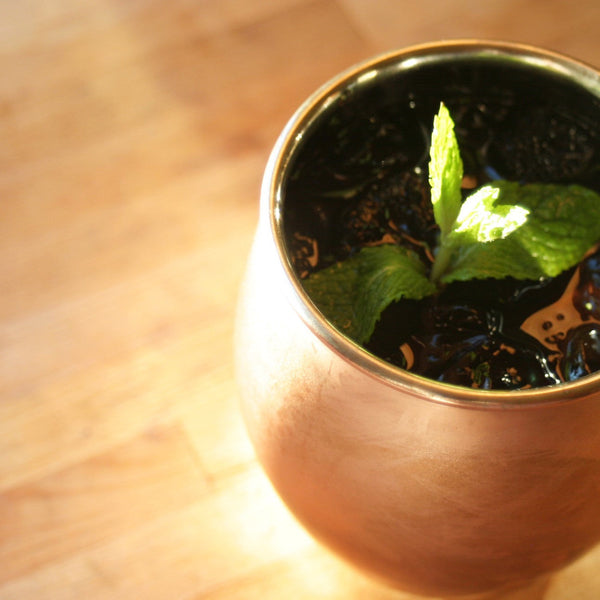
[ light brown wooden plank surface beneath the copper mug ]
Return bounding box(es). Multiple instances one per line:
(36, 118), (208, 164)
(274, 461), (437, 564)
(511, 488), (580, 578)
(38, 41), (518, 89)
(0, 0), (600, 600)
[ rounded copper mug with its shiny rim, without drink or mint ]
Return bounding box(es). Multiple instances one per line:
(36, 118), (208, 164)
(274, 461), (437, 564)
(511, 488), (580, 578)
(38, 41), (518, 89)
(235, 41), (600, 596)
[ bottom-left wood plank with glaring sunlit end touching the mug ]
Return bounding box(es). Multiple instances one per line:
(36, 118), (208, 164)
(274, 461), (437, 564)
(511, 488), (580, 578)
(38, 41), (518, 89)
(0, 467), (315, 600)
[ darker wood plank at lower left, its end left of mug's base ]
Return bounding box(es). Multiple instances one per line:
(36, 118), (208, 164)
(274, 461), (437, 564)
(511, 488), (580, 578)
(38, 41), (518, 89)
(0, 426), (207, 580)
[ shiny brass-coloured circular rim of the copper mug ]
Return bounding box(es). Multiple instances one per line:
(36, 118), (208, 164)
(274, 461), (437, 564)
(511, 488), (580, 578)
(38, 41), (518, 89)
(260, 40), (600, 410)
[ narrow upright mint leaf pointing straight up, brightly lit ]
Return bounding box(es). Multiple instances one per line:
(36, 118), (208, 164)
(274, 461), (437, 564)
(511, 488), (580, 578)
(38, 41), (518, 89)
(429, 104), (463, 240)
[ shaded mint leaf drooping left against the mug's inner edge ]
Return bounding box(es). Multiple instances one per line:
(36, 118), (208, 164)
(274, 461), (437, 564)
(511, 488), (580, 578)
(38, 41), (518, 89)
(302, 244), (436, 344)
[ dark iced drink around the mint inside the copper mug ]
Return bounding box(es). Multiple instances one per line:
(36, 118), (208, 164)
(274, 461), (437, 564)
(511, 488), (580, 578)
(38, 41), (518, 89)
(284, 60), (600, 389)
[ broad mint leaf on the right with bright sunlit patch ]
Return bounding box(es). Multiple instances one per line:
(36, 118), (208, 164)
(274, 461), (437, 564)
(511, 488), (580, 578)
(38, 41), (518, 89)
(440, 181), (600, 283)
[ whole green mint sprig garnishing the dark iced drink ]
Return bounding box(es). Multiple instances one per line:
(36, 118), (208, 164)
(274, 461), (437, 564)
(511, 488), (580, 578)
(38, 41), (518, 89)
(303, 104), (600, 344)
